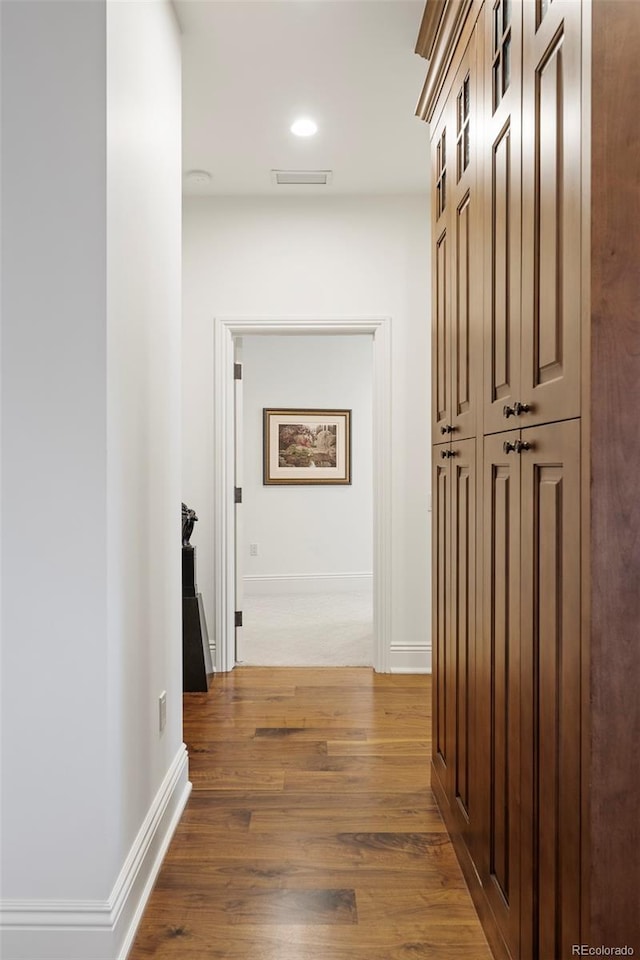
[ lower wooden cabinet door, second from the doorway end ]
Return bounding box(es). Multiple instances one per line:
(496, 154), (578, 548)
(450, 440), (477, 848)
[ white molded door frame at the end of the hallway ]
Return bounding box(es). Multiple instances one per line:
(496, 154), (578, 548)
(213, 317), (392, 673)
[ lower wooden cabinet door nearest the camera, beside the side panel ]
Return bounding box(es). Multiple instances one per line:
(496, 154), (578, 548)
(520, 420), (581, 960)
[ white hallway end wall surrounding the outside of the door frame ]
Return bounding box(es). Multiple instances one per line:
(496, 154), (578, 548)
(183, 193), (430, 670)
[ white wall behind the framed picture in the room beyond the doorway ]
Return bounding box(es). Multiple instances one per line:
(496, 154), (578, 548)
(241, 335), (373, 592)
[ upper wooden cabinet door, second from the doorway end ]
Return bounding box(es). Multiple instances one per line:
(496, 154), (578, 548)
(450, 27), (482, 439)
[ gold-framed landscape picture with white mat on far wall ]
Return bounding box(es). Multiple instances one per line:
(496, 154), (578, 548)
(264, 409), (351, 483)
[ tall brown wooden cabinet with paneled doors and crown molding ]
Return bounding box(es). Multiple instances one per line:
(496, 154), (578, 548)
(416, 0), (640, 960)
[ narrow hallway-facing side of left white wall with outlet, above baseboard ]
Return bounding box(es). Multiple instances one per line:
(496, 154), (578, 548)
(107, 2), (182, 900)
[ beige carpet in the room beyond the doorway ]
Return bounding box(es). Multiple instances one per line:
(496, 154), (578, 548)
(238, 592), (373, 667)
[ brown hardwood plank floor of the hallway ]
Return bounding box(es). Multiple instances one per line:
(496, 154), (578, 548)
(129, 667), (491, 960)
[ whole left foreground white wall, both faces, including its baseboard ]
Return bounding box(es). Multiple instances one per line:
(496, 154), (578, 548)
(0, 0), (188, 960)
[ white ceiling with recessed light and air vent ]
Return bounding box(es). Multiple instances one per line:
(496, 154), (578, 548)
(174, 0), (429, 196)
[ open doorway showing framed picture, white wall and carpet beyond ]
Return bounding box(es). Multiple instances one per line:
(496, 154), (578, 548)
(235, 334), (373, 666)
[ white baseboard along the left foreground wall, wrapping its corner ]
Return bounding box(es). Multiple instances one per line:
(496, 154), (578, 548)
(0, 744), (191, 960)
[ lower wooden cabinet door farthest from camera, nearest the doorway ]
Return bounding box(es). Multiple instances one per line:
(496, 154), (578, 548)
(432, 444), (455, 798)
